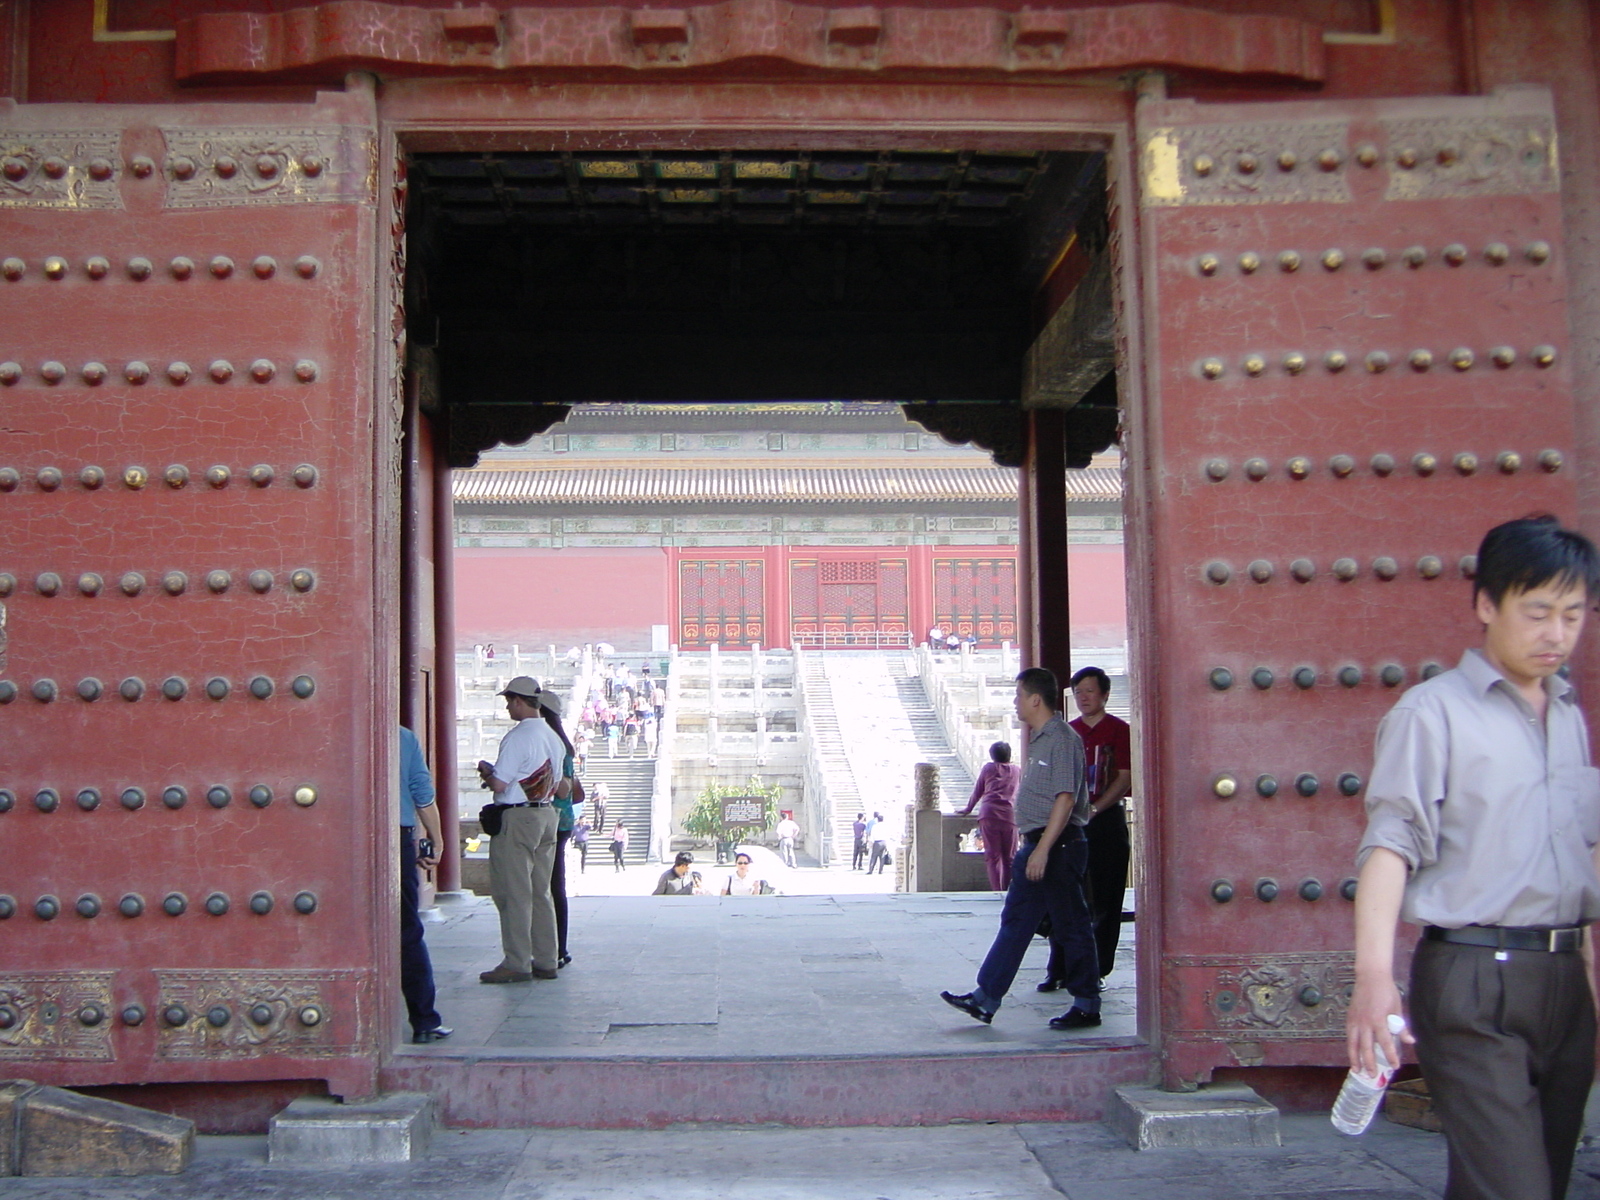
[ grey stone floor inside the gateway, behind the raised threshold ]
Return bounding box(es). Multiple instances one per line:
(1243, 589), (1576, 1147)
(402, 893), (1136, 1058)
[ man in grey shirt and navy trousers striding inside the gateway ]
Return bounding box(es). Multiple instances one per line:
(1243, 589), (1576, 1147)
(939, 667), (1101, 1029)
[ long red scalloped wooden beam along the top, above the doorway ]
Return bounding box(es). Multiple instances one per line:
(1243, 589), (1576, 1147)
(176, 0), (1326, 83)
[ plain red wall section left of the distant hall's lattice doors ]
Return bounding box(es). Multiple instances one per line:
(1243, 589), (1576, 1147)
(454, 547), (670, 651)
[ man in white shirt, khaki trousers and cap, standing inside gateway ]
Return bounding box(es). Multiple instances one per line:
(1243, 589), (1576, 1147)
(478, 675), (571, 984)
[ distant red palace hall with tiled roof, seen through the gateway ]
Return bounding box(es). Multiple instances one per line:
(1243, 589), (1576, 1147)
(454, 402), (1126, 653)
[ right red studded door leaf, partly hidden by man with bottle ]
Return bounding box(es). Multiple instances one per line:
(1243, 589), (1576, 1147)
(1131, 90), (1573, 1082)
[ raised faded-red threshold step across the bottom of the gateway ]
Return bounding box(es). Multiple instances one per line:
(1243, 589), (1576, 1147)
(381, 1042), (1155, 1130)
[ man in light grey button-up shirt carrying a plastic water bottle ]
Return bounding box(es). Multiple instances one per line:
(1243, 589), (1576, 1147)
(1347, 517), (1600, 1200)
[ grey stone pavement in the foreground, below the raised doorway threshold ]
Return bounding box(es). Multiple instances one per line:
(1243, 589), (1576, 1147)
(3, 1102), (1600, 1200)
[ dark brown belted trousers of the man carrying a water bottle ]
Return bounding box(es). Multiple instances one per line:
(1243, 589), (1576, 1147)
(1410, 939), (1595, 1200)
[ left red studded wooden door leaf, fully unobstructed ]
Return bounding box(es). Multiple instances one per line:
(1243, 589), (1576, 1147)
(0, 94), (395, 1093)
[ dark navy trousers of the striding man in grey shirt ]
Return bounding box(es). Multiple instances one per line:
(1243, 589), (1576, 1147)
(973, 827), (1099, 1013)
